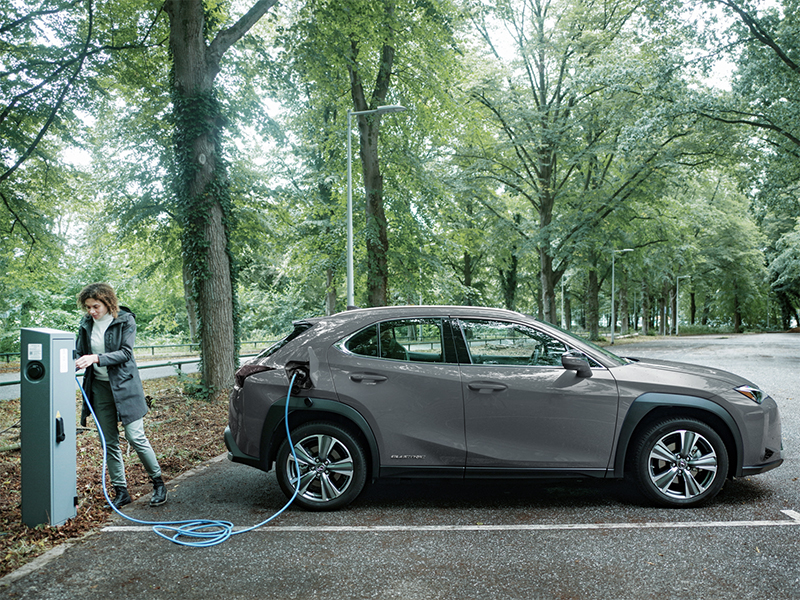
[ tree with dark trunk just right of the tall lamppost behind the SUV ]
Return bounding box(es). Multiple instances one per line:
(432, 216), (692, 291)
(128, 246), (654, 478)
(280, 0), (462, 306)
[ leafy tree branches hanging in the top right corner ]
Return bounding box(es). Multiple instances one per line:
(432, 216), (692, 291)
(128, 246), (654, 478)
(696, 0), (800, 225)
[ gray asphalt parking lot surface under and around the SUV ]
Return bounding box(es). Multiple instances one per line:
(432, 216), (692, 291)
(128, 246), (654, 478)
(0, 334), (800, 600)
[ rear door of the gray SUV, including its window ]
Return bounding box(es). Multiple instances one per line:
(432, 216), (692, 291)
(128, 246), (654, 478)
(328, 318), (466, 470)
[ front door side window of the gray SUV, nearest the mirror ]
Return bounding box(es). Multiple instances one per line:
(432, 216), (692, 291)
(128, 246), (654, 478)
(461, 319), (567, 367)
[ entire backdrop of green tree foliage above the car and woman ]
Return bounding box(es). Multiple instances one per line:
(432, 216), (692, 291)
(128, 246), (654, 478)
(0, 0), (800, 356)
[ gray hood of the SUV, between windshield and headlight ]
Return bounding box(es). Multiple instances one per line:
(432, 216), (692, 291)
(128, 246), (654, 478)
(612, 357), (752, 397)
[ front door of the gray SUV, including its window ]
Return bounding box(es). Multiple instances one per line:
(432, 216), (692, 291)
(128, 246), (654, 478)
(456, 319), (619, 474)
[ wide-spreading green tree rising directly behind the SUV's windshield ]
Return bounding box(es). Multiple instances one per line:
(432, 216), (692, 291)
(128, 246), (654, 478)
(462, 0), (707, 322)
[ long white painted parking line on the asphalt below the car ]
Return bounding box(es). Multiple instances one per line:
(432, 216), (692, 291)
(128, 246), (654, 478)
(102, 510), (800, 533)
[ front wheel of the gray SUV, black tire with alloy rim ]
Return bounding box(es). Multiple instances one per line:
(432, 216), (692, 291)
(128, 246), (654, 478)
(632, 418), (728, 508)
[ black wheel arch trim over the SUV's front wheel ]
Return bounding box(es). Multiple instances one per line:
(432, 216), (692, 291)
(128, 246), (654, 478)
(614, 392), (743, 478)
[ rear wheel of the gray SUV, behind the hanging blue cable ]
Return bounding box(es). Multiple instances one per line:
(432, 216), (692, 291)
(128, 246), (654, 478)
(275, 421), (367, 511)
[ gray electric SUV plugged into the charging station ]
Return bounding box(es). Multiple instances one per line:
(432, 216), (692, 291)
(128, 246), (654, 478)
(225, 306), (783, 510)
